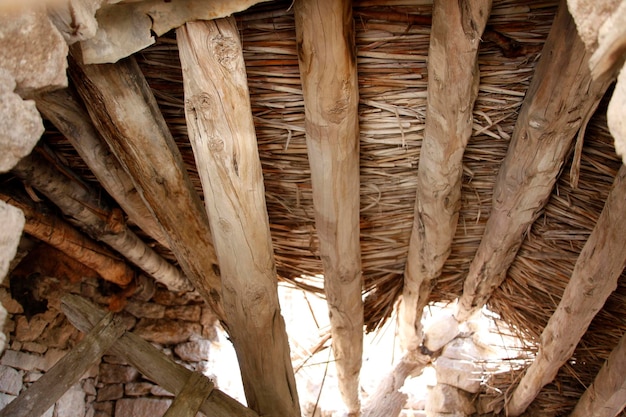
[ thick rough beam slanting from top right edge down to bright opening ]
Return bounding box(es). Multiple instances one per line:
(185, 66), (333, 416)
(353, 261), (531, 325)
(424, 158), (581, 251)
(457, 1), (608, 320)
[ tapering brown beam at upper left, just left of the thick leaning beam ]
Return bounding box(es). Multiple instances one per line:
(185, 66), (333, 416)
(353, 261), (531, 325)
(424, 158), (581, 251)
(36, 89), (168, 247)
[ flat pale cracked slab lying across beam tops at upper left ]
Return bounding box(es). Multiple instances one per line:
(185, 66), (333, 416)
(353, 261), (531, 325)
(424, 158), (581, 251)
(81, 0), (268, 64)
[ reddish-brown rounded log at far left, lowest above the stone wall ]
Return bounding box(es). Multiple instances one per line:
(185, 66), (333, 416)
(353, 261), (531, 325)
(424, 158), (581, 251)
(0, 193), (135, 286)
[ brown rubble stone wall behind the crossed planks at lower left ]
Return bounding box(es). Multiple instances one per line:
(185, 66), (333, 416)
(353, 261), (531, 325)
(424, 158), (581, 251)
(0, 264), (217, 417)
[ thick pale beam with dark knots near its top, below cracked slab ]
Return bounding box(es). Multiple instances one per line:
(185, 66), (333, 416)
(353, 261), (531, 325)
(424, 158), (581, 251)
(176, 18), (300, 417)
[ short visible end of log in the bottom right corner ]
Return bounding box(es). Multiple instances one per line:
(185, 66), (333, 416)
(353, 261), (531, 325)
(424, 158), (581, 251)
(570, 335), (626, 417)
